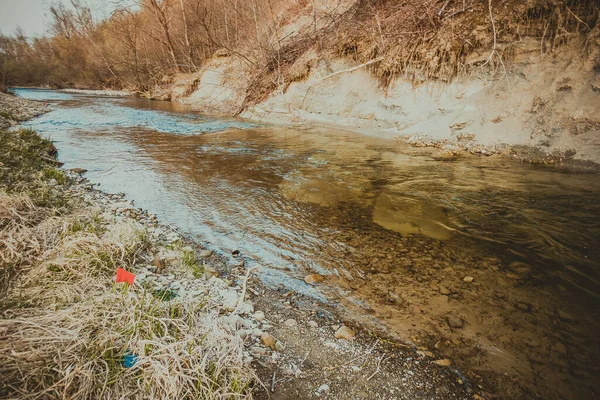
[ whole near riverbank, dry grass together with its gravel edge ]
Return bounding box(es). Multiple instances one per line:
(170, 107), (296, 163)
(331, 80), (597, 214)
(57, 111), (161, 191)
(0, 92), (481, 399)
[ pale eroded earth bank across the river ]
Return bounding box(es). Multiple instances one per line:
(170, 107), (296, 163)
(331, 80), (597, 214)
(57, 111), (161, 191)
(138, 1), (600, 166)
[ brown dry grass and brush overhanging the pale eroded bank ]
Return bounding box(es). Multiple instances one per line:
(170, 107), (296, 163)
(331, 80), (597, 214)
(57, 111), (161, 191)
(244, 0), (600, 107)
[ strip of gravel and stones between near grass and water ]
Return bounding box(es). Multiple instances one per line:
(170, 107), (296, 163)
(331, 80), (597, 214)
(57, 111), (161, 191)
(64, 170), (484, 399)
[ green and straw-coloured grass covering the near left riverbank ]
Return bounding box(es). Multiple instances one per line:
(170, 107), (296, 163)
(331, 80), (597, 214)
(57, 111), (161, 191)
(0, 130), (254, 399)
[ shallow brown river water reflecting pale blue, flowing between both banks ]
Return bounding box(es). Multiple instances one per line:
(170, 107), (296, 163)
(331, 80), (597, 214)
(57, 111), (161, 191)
(19, 90), (600, 398)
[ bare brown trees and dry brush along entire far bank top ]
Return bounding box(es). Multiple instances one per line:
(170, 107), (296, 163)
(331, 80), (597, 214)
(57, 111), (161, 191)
(0, 0), (600, 104)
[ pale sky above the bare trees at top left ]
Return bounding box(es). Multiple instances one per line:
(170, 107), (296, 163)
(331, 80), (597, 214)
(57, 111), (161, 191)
(0, 0), (119, 36)
